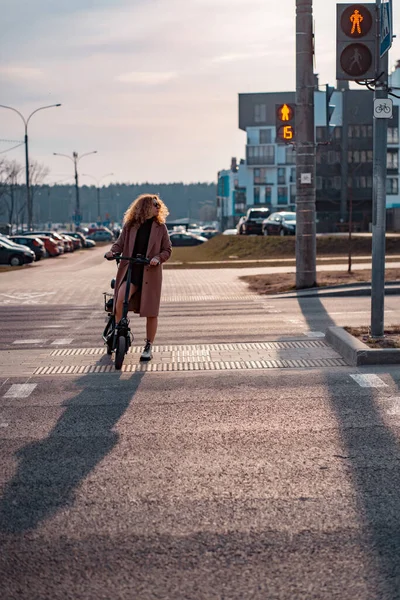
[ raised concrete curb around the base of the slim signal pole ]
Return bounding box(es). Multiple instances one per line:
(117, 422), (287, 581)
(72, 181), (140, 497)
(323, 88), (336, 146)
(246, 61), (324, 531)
(325, 327), (400, 367)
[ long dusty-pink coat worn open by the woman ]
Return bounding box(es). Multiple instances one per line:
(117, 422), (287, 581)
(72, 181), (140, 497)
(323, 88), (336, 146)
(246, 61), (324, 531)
(111, 221), (172, 317)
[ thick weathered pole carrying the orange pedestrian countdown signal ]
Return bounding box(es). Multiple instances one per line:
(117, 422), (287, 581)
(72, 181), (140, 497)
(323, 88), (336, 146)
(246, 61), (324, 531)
(296, 0), (317, 289)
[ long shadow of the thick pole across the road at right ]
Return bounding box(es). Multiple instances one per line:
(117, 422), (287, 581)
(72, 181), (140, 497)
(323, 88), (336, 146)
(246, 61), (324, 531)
(298, 298), (400, 600)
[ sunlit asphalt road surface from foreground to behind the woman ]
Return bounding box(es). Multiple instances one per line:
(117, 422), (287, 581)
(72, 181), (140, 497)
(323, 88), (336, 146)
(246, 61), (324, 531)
(0, 249), (400, 600)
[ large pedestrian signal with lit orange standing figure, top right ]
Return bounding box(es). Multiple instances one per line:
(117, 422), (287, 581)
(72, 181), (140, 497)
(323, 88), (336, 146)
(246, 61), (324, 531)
(336, 4), (377, 81)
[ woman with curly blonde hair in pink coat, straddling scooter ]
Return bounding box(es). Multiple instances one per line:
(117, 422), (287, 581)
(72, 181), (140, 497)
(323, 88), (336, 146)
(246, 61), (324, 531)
(106, 194), (171, 361)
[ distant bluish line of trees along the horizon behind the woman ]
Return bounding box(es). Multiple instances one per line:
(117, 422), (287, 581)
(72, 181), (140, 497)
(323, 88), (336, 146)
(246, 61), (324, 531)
(0, 159), (216, 228)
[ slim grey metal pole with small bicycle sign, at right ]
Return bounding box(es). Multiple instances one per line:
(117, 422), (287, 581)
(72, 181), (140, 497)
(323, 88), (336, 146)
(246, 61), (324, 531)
(371, 0), (388, 338)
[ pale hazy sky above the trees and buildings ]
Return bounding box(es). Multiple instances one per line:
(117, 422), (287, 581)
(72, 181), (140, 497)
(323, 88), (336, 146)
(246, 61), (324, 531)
(0, 0), (400, 184)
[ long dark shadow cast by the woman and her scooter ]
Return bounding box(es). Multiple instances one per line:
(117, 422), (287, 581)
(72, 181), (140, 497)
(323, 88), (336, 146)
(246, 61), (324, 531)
(0, 372), (145, 534)
